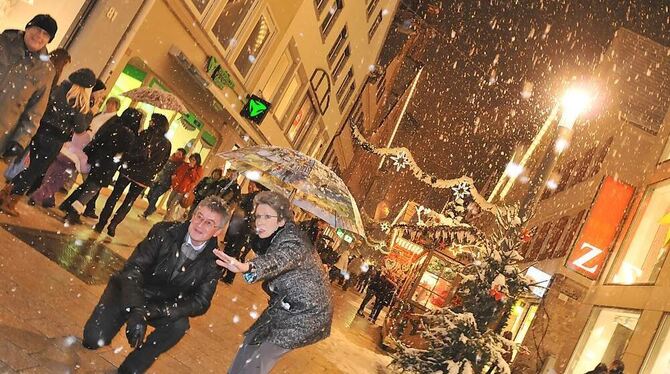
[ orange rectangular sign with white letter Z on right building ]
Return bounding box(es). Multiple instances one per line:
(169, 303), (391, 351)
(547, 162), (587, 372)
(565, 176), (634, 280)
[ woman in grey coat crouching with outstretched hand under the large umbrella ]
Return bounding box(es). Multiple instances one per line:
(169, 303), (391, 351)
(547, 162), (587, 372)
(214, 191), (333, 374)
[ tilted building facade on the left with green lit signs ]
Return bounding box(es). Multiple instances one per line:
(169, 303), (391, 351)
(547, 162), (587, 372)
(5, 0), (398, 167)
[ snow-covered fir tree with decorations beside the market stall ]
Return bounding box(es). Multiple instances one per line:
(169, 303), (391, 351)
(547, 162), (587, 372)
(392, 207), (529, 374)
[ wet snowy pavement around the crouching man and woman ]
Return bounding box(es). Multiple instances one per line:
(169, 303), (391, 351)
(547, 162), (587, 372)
(0, 196), (390, 373)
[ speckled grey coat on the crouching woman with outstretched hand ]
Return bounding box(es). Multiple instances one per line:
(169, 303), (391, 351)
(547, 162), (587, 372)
(245, 223), (333, 349)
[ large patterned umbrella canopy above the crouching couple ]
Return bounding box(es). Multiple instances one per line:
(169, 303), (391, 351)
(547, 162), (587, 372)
(219, 146), (365, 237)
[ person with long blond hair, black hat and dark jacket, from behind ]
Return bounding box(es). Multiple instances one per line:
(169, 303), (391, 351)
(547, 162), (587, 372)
(0, 69), (96, 216)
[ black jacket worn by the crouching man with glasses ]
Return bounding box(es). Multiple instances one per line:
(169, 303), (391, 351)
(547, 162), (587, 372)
(113, 222), (222, 319)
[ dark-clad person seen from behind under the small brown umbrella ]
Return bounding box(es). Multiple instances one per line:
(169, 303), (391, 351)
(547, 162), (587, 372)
(93, 113), (172, 237)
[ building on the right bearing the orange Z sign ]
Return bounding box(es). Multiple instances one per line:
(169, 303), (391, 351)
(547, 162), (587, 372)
(496, 29), (670, 373)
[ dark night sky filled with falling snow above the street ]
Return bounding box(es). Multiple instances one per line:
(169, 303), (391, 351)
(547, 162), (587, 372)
(382, 0), (670, 199)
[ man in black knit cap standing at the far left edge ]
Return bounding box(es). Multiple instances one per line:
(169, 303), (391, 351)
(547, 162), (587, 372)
(0, 14), (58, 160)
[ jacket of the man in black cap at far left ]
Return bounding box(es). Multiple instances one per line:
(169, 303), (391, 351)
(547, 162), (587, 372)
(0, 30), (56, 153)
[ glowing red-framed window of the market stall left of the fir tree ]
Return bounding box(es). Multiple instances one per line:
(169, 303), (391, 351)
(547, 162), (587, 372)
(412, 256), (457, 309)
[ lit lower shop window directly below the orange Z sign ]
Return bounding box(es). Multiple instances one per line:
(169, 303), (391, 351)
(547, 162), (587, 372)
(566, 307), (640, 373)
